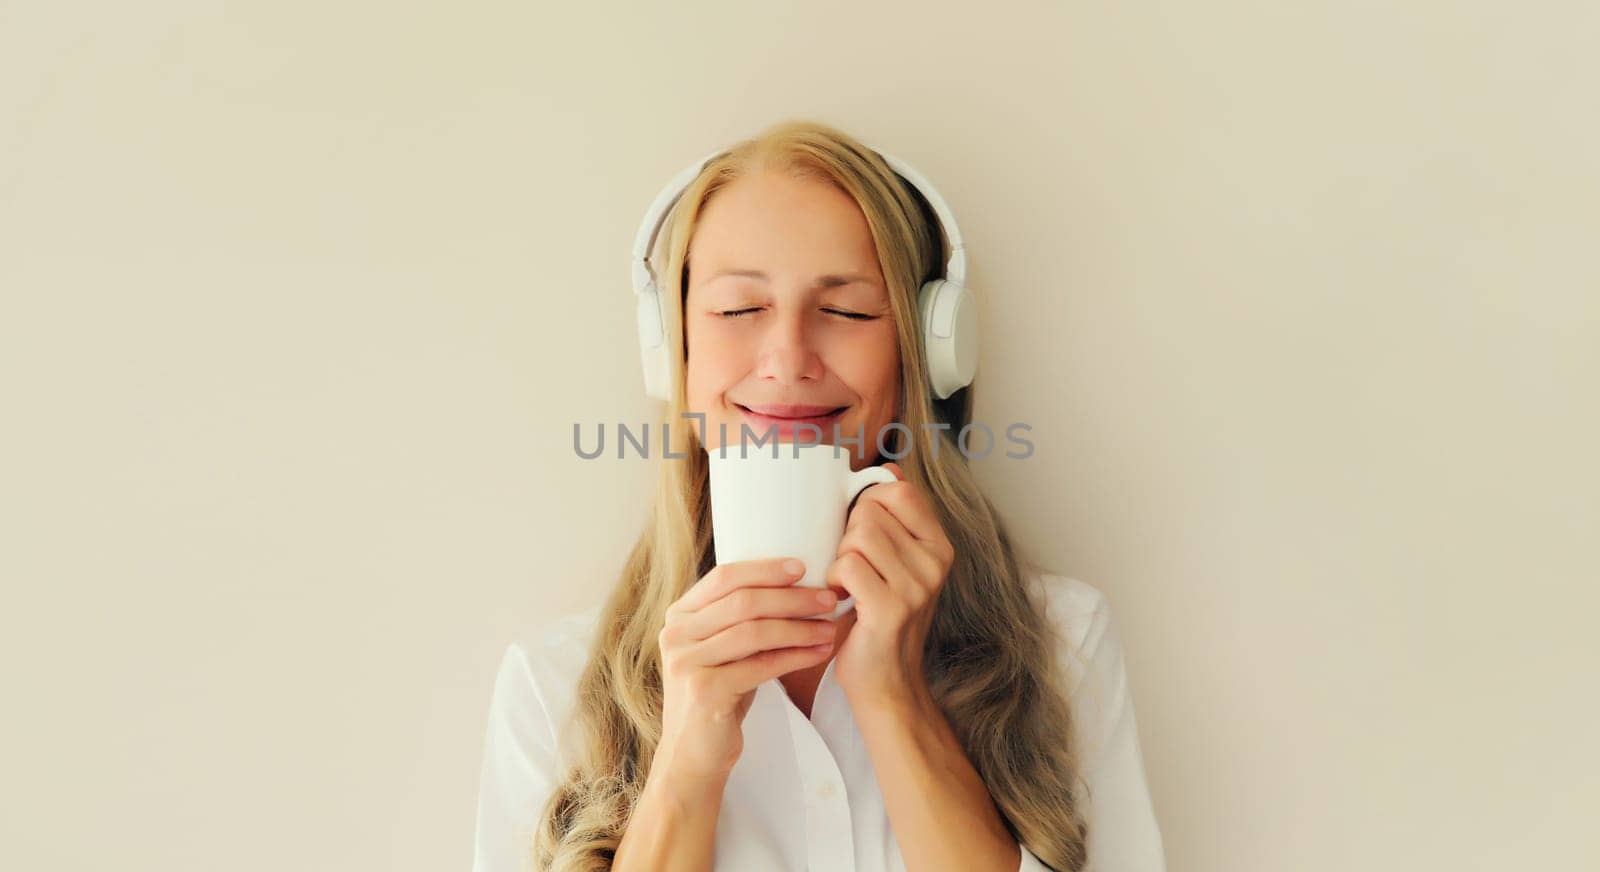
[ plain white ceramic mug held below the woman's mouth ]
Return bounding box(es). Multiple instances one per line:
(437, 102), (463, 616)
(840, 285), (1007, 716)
(707, 442), (898, 621)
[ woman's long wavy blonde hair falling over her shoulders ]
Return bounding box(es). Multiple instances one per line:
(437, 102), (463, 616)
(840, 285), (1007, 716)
(533, 120), (1086, 872)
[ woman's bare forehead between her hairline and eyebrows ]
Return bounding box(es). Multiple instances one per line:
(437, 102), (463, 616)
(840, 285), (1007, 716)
(690, 173), (878, 278)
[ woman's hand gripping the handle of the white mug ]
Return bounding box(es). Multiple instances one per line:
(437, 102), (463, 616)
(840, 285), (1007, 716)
(827, 462), (955, 704)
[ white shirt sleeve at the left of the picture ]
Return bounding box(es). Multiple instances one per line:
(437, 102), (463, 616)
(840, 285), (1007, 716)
(472, 642), (558, 872)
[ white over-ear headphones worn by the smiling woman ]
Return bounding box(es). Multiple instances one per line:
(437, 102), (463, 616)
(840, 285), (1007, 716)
(630, 142), (978, 400)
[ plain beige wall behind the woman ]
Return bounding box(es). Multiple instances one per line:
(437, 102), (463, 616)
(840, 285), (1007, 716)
(0, 0), (1600, 872)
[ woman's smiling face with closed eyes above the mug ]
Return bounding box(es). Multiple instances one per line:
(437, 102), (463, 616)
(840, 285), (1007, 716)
(683, 173), (899, 469)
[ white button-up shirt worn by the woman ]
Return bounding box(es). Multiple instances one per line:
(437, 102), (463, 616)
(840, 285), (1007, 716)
(472, 576), (1165, 872)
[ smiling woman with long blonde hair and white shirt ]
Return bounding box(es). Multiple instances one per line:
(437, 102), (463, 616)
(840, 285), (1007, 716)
(475, 122), (1163, 872)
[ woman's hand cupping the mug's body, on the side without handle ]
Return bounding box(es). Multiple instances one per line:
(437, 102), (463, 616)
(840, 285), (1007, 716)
(651, 558), (837, 782)
